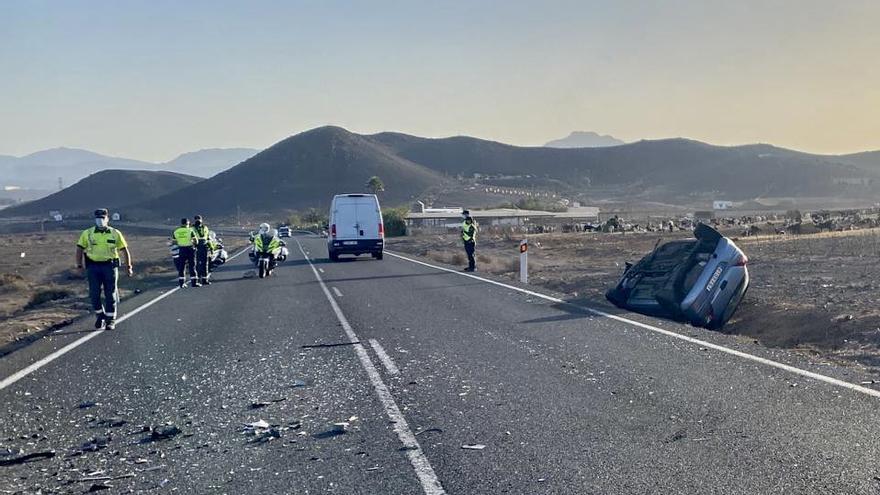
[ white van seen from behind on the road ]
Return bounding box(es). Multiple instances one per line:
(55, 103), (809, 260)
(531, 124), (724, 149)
(327, 194), (385, 261)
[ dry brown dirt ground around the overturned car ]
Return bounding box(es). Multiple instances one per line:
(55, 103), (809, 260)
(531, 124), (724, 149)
(388, 229), (880, 372)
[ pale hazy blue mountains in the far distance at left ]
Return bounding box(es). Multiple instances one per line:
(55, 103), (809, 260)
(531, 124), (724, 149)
(0, 148), (258, 191)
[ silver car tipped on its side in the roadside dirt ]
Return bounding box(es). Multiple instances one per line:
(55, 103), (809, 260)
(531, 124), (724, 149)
(605, 224), (749, 329)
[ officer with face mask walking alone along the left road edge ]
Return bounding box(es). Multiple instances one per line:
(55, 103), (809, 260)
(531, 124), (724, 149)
(76, 208), (134, 330)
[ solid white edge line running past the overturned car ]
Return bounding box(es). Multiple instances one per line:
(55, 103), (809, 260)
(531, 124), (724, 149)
(385, 254), (880, 398)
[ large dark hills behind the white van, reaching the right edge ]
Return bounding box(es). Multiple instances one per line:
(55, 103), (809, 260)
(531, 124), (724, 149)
(4, 126), (880, 219)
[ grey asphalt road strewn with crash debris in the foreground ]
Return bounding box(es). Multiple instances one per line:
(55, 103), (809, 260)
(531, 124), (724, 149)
(0, 237), (880, 494)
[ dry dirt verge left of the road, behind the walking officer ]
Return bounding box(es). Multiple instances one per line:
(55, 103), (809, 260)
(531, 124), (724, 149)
(0, 230), (246, 357)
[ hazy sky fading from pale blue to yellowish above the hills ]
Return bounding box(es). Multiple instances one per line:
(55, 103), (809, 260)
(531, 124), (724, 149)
(0, 0), (880, 161)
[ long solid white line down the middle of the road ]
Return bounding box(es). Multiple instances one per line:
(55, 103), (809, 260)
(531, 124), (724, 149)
(296, 240), (446, 495)
